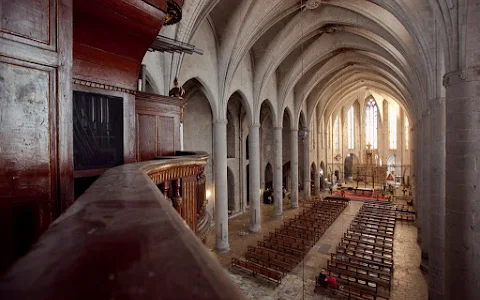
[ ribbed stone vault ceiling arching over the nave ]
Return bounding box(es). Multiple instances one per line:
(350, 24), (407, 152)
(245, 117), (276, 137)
(176, 0), (450, 122)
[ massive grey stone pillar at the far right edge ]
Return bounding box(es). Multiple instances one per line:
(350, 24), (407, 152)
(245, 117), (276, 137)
(444, 68), (480, 300)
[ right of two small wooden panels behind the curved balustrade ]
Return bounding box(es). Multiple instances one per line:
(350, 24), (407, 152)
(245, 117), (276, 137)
(157, 116), (175, 156)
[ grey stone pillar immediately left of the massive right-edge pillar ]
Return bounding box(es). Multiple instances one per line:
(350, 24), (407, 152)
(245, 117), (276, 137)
(428, 99), (445, 300)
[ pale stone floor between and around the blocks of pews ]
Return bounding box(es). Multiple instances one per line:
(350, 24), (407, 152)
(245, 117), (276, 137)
(207, 195), (428, 300)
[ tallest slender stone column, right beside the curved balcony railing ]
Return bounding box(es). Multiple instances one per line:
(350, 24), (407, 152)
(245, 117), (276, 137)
(213, 120), (230, 252)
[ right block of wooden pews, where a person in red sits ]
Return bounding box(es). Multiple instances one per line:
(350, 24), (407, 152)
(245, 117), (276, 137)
(315, 202), (396, 300)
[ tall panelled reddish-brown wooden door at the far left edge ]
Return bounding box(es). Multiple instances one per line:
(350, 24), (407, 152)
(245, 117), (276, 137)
(0, 0), (73, 273)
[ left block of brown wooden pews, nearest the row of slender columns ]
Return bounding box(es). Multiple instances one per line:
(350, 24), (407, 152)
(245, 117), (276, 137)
(232, 199), (349, 284)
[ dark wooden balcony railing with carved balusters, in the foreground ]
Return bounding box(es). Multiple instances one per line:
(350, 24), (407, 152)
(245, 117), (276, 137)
(0, 153), (244, 300)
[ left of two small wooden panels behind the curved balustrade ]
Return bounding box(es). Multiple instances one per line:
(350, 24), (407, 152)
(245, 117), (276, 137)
(137, 114), (157, 161)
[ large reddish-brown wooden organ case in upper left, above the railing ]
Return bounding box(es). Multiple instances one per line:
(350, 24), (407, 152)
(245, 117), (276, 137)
(0, 0), (183, 273)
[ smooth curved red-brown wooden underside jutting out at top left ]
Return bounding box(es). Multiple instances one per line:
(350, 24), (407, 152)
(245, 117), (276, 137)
(73, 0), (166, 90)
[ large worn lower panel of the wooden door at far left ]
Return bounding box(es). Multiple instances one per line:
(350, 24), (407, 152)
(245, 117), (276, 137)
(0, 57), (58, 272)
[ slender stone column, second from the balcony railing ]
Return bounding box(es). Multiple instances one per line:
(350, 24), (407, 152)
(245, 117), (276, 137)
(248, 124), (261, 232)
